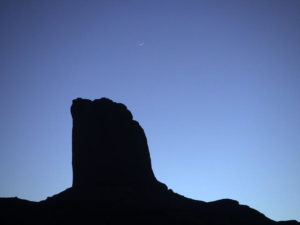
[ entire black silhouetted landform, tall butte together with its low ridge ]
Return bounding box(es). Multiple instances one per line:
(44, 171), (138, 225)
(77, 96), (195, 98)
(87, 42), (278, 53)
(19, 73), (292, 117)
(0, 98), (300, 225)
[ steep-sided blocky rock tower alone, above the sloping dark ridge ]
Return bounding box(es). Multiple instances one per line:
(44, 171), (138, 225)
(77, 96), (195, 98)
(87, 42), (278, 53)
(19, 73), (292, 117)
(71, 98), (156, 188)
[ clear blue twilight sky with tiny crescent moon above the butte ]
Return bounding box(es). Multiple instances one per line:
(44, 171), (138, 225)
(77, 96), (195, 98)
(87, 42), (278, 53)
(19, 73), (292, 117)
(0, 0), (300, 221)
